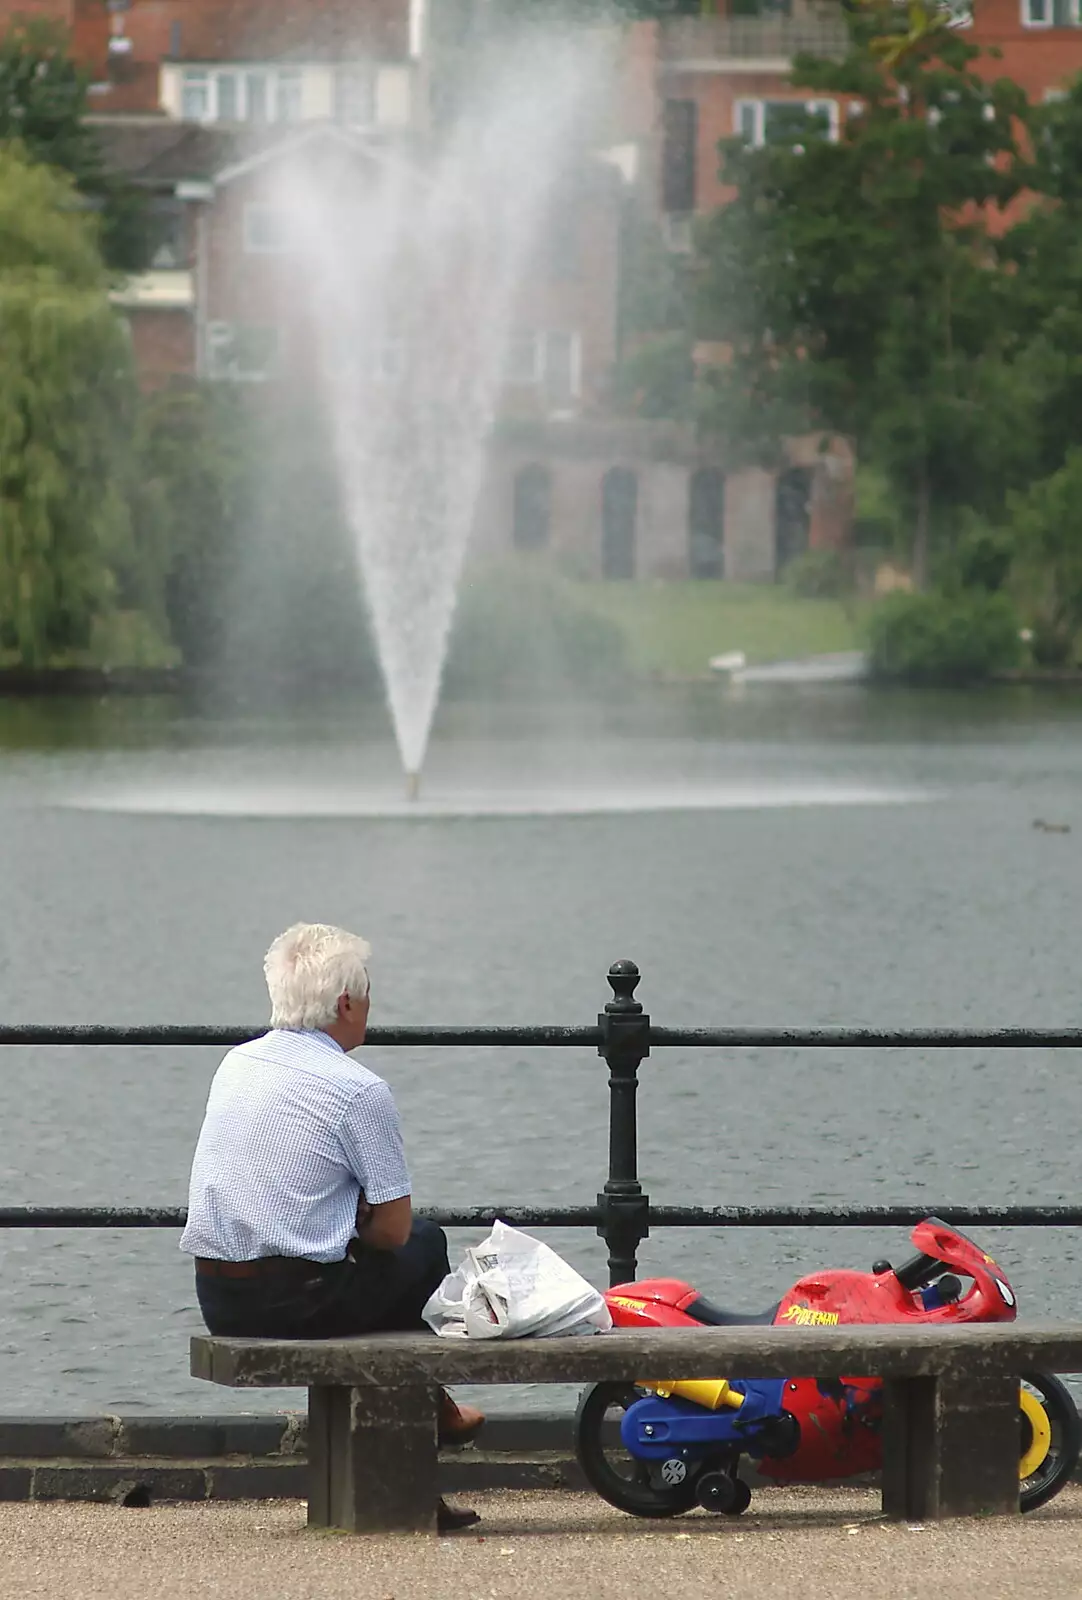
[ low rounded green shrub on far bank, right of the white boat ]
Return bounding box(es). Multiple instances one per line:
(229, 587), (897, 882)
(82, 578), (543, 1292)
(869, 590), (1021, 683)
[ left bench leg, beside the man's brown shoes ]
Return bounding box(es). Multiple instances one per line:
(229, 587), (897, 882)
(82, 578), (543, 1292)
(307, 1384), (439, 1533)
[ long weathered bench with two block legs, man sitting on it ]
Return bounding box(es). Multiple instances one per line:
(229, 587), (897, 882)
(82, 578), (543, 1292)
(192, 1323), (1082, 1533)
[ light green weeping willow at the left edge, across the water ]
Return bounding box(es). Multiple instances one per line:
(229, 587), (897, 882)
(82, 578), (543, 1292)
(0, 146), (134, 667)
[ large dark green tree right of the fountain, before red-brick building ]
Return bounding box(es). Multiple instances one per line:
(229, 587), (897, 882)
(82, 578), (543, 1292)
(698, 0), (1032, 581)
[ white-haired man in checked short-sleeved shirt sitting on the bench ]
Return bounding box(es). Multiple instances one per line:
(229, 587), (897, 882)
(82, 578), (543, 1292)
(181, 923), (485, 1531)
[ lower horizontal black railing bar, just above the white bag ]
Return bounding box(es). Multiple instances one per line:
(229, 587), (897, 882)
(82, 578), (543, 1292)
(0, 1205), (1082, 1229)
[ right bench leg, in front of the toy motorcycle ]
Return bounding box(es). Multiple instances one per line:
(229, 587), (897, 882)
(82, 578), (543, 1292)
(882, 1376), (1020, 1522)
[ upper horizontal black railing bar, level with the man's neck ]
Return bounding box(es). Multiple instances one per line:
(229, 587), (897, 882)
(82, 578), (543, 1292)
(0, 1022), (1082, 1050)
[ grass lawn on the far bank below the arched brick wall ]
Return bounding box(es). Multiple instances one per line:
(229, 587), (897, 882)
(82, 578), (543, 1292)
(573, 582), (871, 677)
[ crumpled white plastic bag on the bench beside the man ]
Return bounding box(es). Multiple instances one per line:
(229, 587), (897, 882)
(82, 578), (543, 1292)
(423, 1221), (613, 1339)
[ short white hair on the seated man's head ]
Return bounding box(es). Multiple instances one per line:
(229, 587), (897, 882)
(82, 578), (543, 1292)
(262, 922), (371, 1032)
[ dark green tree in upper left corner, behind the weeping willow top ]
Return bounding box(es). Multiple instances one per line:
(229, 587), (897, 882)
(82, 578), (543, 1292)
(0, 18), (152, 272)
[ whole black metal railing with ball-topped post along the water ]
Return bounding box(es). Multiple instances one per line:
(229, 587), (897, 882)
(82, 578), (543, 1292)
(0, 962), (1082, 1283)
